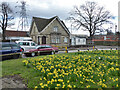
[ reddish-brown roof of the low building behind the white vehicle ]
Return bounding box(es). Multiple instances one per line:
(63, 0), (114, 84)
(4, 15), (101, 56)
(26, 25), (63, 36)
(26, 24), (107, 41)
(5, 30), (28, 37)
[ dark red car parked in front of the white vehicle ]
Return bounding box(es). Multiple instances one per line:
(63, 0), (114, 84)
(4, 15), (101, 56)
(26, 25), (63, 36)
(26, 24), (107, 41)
(24, 45), (57, 56)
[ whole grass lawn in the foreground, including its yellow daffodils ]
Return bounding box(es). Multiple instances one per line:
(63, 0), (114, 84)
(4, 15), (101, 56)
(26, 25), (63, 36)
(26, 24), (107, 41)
(0, 50), (120, 88)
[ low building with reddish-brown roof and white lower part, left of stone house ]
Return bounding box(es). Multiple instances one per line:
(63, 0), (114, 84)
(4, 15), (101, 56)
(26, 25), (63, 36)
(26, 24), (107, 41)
(5, 30), (32, 41)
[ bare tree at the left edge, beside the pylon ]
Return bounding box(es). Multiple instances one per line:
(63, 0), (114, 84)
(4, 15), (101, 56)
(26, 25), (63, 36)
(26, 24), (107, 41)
(0, 2), (13, 40)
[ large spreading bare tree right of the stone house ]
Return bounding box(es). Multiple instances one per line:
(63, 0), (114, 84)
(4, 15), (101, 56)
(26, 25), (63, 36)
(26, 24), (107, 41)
(68, 2), (112, 38)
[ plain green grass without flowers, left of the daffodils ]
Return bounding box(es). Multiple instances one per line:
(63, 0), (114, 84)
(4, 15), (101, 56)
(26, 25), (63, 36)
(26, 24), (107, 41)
(0, 54), (65, 88)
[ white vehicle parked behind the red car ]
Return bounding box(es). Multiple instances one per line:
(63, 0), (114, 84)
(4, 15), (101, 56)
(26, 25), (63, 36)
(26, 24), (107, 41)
(15, 41), (37, 51)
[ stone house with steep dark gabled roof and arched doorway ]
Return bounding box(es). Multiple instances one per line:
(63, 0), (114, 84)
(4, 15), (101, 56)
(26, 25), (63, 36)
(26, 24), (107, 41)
(30, 16), (70, 46)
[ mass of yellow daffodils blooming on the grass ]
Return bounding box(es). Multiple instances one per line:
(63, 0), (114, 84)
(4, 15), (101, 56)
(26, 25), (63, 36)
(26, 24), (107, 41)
(23, 50), (120, 89)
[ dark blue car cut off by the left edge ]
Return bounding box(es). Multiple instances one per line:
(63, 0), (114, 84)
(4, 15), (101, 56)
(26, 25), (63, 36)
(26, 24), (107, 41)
(0, 42), (22, 60)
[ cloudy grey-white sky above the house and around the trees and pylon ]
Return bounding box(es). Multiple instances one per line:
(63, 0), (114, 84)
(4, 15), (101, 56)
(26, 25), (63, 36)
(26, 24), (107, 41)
(0, 0), (119, 33)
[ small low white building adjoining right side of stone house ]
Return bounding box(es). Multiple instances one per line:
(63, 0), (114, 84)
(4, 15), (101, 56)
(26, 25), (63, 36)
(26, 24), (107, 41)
(71, 34), (87, 46)
